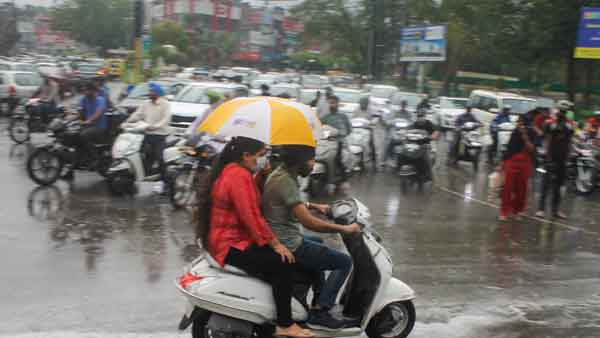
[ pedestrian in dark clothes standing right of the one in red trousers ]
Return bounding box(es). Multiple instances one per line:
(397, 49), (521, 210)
(536, 101), (575, 219)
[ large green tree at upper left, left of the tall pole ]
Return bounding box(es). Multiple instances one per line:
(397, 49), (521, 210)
(50, 0), (133, 51)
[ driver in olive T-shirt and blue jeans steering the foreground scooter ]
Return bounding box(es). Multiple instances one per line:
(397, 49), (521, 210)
(262, 145), (360, 329)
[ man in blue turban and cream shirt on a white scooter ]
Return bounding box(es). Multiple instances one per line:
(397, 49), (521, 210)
(125, 82), (171, 182)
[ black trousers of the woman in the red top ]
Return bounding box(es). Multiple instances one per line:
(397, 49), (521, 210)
(225, 245), (295, 327)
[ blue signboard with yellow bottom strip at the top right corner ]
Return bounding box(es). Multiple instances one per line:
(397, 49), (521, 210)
(575, 7), (600, 59)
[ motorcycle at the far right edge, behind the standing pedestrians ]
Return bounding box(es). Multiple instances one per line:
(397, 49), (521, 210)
(573, 142), (600, 195)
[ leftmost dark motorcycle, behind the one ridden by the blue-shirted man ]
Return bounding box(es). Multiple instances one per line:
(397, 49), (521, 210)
(8, 98), (65, 144)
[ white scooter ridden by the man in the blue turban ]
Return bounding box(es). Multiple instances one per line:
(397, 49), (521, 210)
(107, 121), (160, 195)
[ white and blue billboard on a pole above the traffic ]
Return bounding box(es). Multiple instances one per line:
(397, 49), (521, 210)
(400, 25), (447, 62)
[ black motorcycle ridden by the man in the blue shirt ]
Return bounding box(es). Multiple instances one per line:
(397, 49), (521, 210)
(27, 115), (111, 185)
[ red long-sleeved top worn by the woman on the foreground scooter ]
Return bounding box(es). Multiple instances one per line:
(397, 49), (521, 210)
(208, 163), (275, 265)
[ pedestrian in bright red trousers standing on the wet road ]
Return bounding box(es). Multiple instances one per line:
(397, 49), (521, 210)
(500, 116), (535, 221)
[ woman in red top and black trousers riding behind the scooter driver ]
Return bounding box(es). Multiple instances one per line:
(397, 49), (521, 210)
(199, 137), (313, 338)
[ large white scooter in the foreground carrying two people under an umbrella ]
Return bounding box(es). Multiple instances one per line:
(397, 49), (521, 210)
(175, 199), (415, 338)
